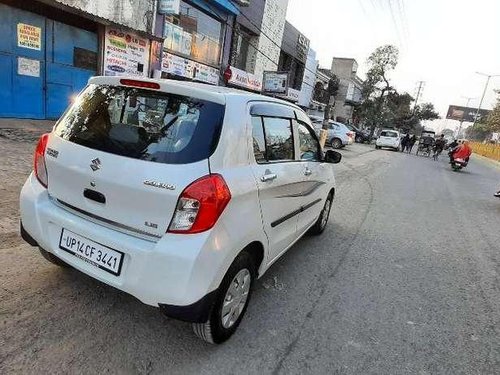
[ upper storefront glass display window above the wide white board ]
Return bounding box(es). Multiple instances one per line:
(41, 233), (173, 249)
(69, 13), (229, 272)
(163, 2), (223, 66)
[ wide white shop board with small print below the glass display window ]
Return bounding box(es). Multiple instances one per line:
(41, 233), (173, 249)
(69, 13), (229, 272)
(161, 52), (219, 85)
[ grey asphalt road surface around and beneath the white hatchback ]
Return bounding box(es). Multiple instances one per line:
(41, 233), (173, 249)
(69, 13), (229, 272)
(0, 139), (500, 375)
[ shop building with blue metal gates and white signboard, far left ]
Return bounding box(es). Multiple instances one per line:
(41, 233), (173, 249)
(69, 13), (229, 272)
(0, 0), (156, 119)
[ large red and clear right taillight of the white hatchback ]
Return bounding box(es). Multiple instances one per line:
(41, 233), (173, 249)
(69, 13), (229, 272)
(168, 174), (231, 233)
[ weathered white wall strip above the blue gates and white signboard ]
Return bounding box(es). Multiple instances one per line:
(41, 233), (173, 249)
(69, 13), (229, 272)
(53, 0), (156, 32)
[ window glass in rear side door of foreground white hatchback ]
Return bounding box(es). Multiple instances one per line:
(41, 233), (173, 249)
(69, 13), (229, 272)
(252, 116), (295, 163)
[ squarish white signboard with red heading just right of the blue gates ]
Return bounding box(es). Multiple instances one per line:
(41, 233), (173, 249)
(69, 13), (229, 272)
(104, 27), (150, 77)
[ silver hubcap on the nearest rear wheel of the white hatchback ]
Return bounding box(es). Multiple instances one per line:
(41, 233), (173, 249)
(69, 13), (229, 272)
(221, 268), (252, 328)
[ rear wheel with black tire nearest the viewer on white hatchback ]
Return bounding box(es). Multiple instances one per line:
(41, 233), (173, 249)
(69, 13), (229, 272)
(192, 251), (256, 344)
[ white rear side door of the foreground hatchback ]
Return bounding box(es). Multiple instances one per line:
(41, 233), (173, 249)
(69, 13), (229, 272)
(251, 103), (303, 261)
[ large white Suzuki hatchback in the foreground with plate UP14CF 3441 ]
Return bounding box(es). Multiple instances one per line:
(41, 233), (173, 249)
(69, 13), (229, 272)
(20, 77), (341, 343)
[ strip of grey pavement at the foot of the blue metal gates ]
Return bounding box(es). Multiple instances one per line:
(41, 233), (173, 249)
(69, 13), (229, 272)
(0, 118), (55, 142)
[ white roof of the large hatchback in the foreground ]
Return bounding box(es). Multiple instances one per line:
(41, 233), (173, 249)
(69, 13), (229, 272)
(89, 76), (300, 109)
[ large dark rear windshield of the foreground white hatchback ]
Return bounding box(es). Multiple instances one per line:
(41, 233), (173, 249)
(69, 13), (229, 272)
(55, 85), (225, 164)
